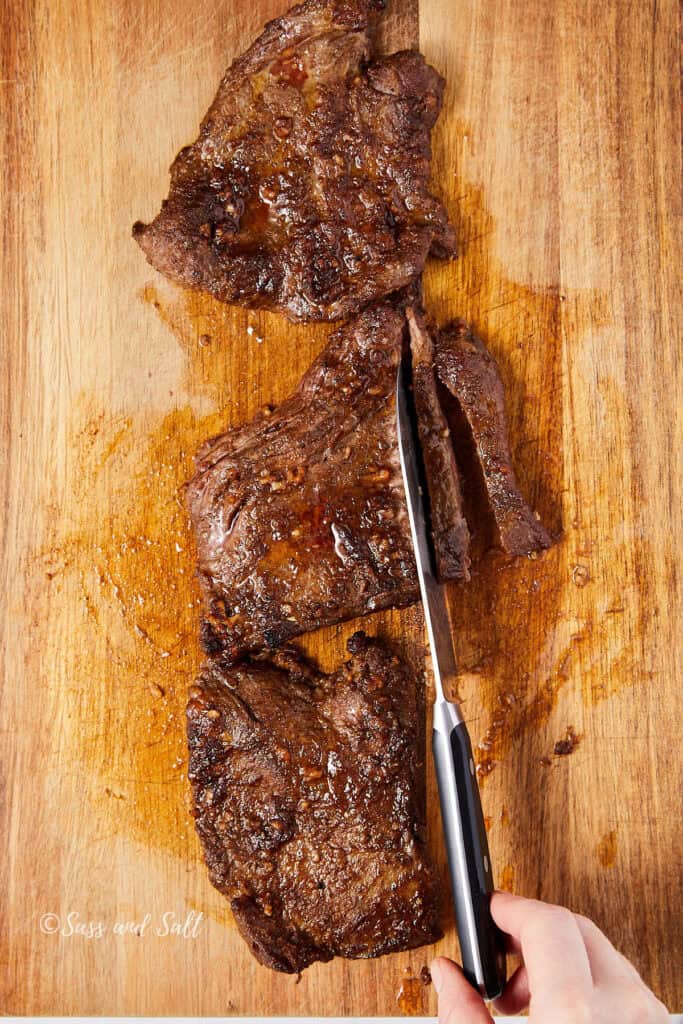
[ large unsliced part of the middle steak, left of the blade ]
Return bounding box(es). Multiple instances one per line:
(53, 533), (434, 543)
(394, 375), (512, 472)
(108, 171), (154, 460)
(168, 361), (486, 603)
(187, 303), (418, 658)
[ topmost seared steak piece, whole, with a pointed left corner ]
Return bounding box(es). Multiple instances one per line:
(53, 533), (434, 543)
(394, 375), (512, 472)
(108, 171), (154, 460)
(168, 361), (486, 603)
(133, 0), (455, 321)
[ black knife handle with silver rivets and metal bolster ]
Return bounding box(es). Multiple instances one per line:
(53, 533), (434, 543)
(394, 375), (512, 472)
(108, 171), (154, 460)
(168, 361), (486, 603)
(432, 701), (506, 999)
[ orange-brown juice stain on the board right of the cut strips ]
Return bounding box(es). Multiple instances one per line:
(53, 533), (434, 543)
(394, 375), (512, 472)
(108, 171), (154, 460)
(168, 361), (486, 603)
(425, 174), (647, 781)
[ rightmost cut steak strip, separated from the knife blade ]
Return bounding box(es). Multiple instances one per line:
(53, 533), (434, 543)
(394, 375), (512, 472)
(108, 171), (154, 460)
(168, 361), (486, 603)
(436, 321), (552, 555)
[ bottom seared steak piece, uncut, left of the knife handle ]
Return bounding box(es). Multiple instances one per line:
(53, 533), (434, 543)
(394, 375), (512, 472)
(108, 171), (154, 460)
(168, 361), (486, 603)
(187, 633), (441, 973)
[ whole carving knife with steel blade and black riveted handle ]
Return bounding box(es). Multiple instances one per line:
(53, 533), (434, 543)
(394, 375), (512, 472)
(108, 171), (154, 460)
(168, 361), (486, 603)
(396, 354), (506, 999)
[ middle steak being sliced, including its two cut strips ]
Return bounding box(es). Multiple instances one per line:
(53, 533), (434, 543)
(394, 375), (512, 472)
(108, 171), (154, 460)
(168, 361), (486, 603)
(187, 302), (550, 659)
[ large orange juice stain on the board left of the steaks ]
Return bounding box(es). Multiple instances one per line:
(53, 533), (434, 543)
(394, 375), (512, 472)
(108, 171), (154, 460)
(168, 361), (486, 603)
(30, 396), (224, 876)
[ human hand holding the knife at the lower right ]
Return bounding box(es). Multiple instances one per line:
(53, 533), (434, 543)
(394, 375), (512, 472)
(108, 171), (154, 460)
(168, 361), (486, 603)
(431, 893), (669, 1024)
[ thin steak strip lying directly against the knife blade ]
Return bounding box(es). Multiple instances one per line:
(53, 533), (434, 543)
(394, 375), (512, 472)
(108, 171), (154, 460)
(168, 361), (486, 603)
(407, 308), (470, 580)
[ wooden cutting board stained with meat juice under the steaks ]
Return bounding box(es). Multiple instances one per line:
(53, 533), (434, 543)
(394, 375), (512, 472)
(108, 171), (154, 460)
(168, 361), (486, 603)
(0, 0), (683, 1016)
